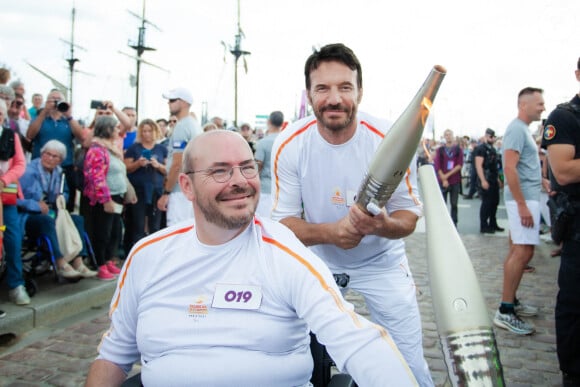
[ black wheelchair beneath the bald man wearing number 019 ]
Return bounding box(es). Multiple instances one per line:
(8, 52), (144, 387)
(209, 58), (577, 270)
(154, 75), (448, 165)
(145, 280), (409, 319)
(121, 332), (357, 387)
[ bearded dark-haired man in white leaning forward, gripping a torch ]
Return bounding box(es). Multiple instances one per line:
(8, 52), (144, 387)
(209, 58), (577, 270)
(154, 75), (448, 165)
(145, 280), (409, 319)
(272, 44), (433, 386)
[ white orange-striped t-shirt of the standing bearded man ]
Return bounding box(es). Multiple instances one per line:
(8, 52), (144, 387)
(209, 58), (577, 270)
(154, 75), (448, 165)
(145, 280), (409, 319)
(271, 112), (422, 271)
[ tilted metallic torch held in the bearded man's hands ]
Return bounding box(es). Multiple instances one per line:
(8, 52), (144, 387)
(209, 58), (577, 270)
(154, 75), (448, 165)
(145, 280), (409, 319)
(356, 65), (446, 215)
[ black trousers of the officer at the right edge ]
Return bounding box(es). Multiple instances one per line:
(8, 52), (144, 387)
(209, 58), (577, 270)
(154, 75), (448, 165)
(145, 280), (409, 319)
(556, 221), (580, 385)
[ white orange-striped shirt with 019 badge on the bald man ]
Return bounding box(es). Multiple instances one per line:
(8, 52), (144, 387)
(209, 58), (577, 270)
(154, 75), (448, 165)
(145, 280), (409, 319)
(99, 217), (416, 387)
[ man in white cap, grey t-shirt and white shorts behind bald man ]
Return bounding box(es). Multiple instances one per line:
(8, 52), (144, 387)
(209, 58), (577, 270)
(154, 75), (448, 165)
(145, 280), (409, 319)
(157, 87), (202, 226)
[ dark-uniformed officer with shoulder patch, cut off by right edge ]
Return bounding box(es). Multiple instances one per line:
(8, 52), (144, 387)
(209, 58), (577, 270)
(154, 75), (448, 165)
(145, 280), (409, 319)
(542, 59), (580, 386)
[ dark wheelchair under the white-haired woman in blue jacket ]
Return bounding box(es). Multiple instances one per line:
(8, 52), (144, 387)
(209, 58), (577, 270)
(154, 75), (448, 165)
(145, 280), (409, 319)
(22, 232), (97, 297)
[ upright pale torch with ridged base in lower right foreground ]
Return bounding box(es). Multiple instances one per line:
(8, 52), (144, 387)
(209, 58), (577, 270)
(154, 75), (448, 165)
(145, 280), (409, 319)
(419, 164), (505, 387)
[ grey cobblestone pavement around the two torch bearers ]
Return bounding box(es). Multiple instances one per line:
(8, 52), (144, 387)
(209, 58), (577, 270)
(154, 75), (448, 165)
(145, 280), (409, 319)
(0, 232), (561, 387)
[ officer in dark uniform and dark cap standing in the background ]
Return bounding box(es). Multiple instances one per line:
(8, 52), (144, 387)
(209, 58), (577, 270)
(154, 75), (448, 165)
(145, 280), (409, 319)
(473, 128), (504, 234)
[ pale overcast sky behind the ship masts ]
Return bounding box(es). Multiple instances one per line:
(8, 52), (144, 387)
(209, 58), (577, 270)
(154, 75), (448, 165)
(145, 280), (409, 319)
(0, 0), (580, 135)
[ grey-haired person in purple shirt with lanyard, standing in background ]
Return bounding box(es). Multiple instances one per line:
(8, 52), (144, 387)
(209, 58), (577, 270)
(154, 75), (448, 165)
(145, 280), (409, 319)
(434, 129), (463, 227)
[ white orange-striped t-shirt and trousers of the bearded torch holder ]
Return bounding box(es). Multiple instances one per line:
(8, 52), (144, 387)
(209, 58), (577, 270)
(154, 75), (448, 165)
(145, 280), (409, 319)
(271, 112), (433, 386)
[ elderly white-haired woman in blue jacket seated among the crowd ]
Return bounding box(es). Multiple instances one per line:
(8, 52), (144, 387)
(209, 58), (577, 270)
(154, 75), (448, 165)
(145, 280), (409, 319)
(18, 140), (97, 279)
